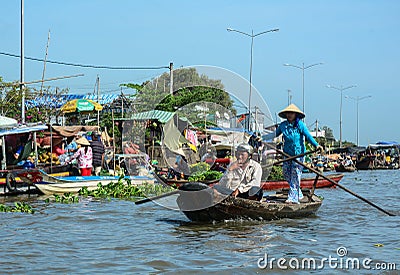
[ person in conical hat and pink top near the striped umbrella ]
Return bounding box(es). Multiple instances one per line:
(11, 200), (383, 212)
(68, 137), (93, 176)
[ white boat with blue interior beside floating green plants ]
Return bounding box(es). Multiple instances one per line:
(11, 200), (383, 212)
(17, 170), (154, 195)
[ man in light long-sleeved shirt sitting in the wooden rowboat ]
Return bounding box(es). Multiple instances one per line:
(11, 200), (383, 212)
(219, 143), (263, 200)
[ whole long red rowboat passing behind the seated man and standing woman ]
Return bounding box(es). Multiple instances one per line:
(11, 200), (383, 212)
(155, 173), (344, 190)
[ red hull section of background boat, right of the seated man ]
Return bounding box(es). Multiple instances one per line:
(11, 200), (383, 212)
(261, 174), (344, 190)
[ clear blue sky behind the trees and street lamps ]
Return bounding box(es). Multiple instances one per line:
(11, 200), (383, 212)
(0, 0), (400, 145)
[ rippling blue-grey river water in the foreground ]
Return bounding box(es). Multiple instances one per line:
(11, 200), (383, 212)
(0, 170), (400, 274)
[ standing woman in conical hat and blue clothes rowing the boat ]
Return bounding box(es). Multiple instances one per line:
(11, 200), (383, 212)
(275, 104), (322, 203)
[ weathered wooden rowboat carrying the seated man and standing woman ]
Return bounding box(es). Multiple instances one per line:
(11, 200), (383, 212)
(177, 183), (322, 222)
